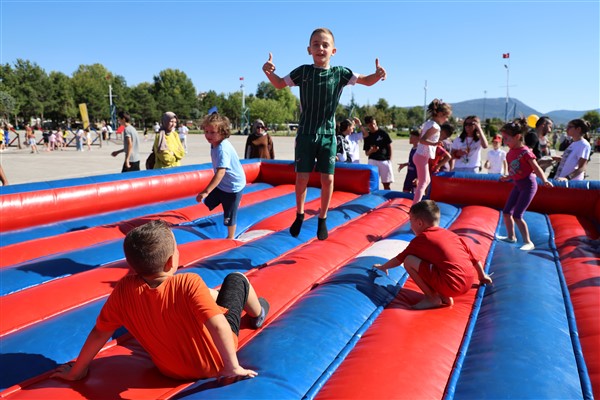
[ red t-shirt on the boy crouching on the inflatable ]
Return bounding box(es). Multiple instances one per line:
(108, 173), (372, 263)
(396, 226), (478, 296)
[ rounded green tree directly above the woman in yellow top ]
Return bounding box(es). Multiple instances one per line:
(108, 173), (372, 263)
(153, 68), (197, 119)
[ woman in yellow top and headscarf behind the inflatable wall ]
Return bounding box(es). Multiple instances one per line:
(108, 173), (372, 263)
(152, 111), (185, 169)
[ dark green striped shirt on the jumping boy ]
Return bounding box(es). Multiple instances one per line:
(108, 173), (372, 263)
(285, 65), (356, 135)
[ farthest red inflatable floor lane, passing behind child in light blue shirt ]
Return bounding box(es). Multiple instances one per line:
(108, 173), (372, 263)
(0, 185), (294, 268)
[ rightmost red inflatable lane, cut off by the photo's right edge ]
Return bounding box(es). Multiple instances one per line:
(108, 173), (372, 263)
(550, 215), (600, 399)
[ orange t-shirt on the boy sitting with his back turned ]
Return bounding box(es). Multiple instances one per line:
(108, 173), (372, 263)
(96, 273), (237, 379)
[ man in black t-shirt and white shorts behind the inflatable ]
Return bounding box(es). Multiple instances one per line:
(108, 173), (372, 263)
(363, 115), (394, 190)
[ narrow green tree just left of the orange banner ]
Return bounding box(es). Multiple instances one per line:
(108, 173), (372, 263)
(46, 71), (77, 122)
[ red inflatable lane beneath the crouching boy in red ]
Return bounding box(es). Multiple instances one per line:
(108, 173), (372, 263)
(317, 206), (499, 399)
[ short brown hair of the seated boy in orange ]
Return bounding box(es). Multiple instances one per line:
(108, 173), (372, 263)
(123, 219), (175, 276)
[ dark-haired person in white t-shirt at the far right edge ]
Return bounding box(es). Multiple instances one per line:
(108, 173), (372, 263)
(554, 118), (592, 181)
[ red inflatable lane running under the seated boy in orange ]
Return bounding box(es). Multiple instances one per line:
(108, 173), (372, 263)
(3, 198), (411, 399)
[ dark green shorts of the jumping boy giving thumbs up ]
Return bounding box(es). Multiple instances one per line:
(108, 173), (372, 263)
(294, 135), (337, 175)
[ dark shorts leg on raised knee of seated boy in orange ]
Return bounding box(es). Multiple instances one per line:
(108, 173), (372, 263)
(217, 272), (250, 336)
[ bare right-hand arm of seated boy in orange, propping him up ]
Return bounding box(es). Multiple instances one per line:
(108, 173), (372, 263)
(206, 314), (258, 378)
